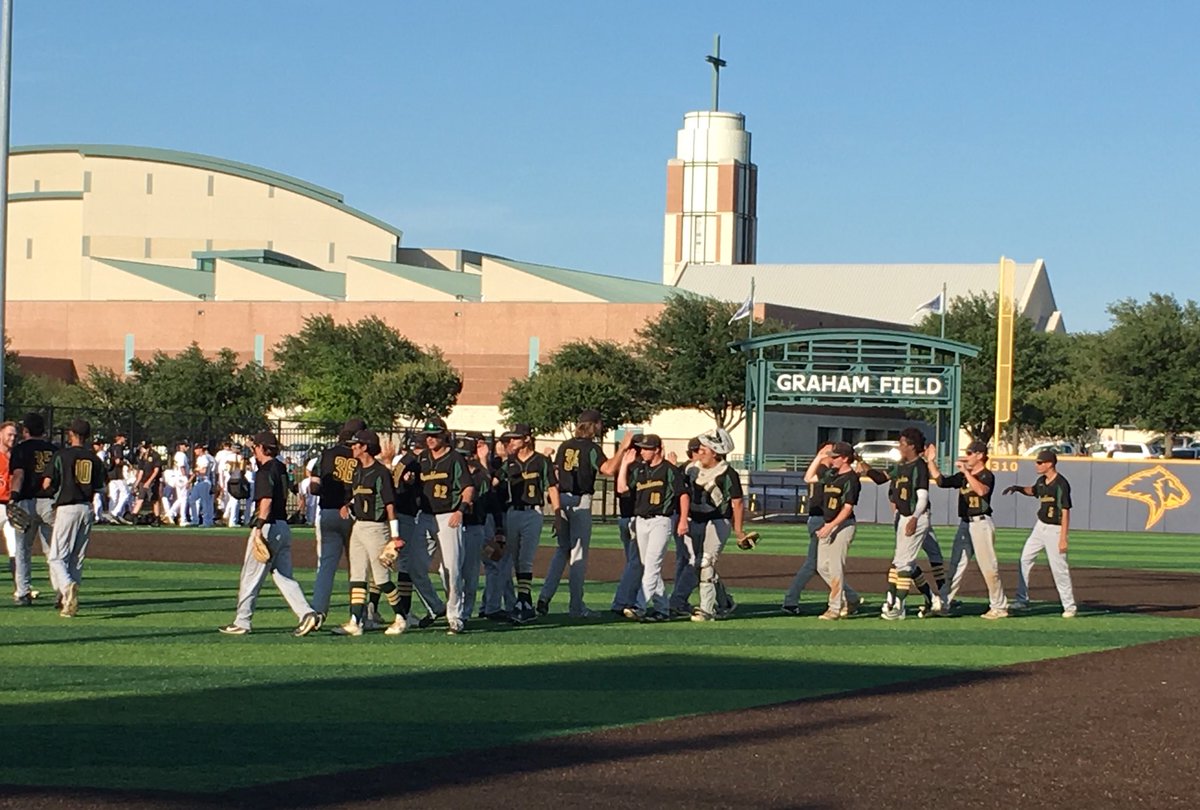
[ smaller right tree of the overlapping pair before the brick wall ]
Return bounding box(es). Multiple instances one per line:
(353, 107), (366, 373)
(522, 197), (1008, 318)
(361, 349), (462, 425)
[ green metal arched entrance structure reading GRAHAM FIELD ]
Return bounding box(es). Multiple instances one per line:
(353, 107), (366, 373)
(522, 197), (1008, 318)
(731, 329), (979, 469)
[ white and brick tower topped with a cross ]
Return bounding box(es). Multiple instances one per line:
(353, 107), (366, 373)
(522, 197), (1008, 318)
(662, 37), (758, 284)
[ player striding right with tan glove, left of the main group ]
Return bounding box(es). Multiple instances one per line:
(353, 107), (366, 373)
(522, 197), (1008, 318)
(218, 431), (320, 636)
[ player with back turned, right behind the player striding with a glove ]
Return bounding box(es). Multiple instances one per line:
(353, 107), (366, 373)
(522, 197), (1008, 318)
(308, 419), (366, 623)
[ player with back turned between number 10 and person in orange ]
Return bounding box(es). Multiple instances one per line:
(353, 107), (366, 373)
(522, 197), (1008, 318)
(8, 413), (61, 607)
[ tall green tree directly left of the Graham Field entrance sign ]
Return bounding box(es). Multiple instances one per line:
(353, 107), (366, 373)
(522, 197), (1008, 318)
(637, 294), (786, 430)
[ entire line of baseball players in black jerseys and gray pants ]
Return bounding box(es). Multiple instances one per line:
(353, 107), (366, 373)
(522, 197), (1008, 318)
(0, 409), (1076, 636)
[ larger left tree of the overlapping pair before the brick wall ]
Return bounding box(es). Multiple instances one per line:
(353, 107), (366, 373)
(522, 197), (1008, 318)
(274, 314), (426, 422)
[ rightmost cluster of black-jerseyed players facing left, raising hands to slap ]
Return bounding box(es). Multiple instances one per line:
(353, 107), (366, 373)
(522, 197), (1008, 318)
(784, 427), (1076, 622)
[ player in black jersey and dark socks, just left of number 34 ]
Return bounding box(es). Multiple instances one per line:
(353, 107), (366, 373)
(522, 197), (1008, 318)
(497, 425), (562, 624)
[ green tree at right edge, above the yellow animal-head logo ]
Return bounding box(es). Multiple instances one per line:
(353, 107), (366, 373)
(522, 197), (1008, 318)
(1104, 293), (1200, 448)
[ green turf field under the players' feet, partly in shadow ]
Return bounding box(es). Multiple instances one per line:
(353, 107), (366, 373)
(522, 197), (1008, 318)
(0, 527), (1200, 791)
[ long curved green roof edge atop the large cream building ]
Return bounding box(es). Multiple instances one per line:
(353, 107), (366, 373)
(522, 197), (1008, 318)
(11, 144), (403, 239)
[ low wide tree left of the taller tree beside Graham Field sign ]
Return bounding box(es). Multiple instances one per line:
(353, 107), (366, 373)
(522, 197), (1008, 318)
(500, 340), (659, 433)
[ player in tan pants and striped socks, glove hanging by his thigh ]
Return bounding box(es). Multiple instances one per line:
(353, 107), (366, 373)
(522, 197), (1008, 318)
(334, 430), (408, 636)
